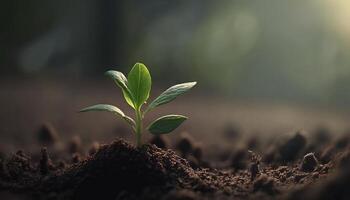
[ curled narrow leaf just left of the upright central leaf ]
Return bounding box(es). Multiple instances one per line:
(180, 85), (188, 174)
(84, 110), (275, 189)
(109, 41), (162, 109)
(105, 70), (135, 108)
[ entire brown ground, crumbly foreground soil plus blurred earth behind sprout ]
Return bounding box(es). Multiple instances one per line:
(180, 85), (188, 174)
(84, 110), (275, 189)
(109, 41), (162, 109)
(0, 79), (350, 199)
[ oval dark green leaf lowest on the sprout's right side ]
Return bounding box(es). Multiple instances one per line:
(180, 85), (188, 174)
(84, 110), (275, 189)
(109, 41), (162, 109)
(147, 115), (187, 135)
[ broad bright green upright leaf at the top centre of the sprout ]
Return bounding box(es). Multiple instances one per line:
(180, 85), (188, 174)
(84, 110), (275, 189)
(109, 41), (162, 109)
(128, 63), (152, 109)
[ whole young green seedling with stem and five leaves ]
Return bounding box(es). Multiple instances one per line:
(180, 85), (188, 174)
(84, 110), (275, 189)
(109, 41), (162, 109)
(80, 63), (196, 147)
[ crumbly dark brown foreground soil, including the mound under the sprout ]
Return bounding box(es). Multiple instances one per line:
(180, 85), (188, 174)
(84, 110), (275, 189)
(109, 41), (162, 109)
(0, 134), (350, 199)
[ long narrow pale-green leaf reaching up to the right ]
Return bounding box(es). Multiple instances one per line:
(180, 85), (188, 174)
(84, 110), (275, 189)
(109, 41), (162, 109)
(147, 82), (197, 111)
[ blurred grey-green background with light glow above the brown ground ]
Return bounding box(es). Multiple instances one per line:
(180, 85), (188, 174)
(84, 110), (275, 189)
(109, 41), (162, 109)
(0, 0), (350, 106)
